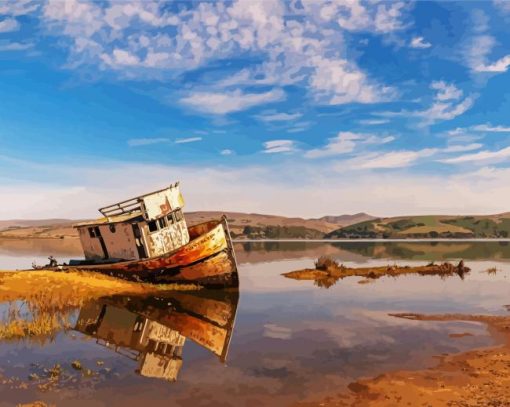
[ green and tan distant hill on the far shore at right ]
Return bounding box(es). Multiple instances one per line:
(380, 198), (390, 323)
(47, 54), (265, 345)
(325, 212), (510, 239)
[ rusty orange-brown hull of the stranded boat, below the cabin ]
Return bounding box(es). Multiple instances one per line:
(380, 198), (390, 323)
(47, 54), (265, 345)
(57, 217), (239, 288)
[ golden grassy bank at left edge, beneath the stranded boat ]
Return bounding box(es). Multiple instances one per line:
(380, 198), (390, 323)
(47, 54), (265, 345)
(0, 270), (199, 343)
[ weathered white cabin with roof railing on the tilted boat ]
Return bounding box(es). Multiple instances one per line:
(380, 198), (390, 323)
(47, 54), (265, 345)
(74, 182), (189, 261)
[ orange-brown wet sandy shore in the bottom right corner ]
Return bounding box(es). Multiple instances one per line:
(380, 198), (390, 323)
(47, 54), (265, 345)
(299, 314), (510, 407)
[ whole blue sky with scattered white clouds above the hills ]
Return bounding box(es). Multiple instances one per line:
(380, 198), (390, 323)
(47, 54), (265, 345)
(0, 0), (510, 219)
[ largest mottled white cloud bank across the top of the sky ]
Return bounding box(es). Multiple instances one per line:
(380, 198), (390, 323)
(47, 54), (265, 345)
(36, 0), (402, 107)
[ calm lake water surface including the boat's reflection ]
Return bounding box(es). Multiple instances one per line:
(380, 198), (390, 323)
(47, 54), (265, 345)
(0, 241), (510, 407)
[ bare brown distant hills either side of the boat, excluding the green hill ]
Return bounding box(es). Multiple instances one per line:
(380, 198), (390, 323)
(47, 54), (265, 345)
(0, 212), (369, 239)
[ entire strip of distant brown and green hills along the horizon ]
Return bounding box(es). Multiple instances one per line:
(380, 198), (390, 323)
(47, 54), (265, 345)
(5, 211), (510, 239)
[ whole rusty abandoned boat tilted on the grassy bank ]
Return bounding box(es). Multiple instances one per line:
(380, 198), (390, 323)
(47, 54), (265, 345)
(42, 182), (238, 287)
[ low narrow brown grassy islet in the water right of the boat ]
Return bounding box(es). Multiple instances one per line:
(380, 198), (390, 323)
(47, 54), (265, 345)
(282, 257), (470, 288)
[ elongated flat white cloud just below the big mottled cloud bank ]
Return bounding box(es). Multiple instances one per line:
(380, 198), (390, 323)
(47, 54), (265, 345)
(180, 89), (285, 115)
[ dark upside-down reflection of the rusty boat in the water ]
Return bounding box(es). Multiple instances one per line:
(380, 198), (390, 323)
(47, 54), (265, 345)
(75, 290), (239, 381)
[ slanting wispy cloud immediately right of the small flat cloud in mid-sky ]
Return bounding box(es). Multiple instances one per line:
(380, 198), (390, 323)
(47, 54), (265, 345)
(305, 131), (395, 158)
